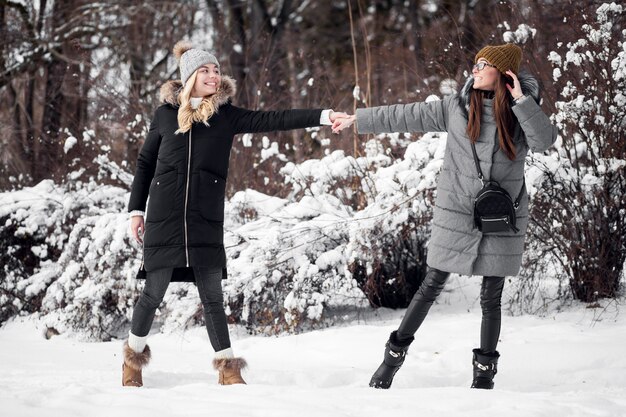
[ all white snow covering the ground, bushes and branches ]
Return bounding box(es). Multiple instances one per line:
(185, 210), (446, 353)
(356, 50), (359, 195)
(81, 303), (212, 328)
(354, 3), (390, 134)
(0, 1), (626, 417)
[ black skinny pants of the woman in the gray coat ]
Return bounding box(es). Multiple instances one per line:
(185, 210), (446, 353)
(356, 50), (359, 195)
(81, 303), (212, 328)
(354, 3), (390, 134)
(397, 267), (504, 353)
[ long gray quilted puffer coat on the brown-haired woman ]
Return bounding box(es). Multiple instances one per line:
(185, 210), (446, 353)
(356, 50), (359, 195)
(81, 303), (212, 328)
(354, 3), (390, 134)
(356, 74), (557, 276)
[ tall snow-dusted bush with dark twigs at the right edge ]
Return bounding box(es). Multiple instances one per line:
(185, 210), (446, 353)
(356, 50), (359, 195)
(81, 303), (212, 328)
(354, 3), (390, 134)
(526, 3), (626, 302)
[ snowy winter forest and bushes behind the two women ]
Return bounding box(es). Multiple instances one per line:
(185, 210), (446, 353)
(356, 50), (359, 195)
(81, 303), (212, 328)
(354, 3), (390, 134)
(0, 0), (626, 340)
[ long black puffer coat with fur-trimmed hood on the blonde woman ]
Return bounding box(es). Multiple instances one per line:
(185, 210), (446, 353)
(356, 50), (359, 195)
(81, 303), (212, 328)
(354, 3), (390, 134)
(128, 76), (322, 281)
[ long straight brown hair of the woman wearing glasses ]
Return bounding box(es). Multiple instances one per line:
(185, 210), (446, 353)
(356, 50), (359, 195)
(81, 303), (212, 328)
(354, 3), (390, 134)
(466, 72), (515, 161)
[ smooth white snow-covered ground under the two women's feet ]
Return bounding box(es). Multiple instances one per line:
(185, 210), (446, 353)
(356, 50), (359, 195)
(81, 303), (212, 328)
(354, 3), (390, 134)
(0, 278), (626, 417)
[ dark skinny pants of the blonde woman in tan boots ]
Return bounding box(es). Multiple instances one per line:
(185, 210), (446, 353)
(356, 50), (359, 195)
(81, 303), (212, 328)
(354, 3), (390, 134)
(130, 268), (230, 352)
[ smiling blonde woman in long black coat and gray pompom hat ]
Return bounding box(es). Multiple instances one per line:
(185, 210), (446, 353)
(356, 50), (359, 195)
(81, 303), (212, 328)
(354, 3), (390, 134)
(122, 41), (346, 386)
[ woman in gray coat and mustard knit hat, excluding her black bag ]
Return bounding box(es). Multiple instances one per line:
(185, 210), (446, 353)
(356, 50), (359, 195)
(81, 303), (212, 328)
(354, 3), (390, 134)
(333, 44), (557, 389)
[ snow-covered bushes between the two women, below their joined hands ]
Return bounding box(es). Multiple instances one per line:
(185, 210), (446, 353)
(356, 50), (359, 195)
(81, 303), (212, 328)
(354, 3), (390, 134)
(211, 135), (445, 333)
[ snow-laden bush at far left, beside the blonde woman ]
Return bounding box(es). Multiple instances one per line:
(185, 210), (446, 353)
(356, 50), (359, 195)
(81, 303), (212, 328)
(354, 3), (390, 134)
(0, 180), (139, 340)
